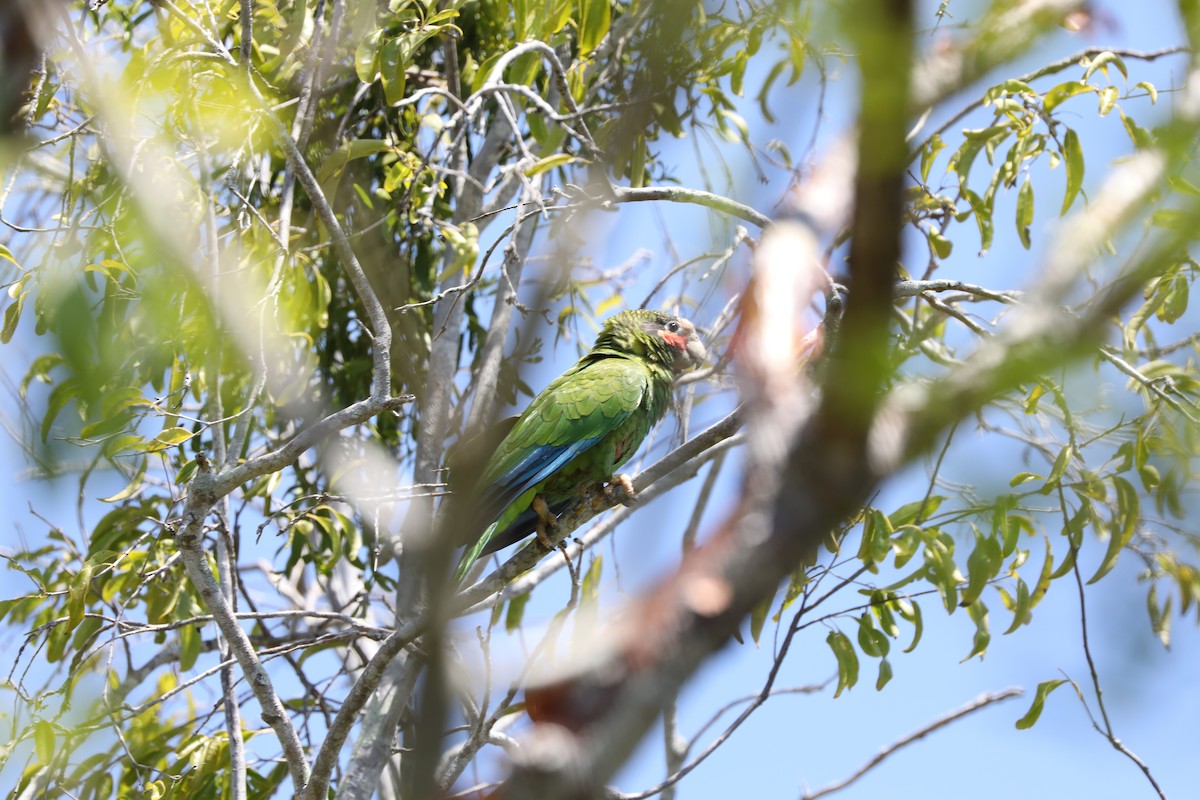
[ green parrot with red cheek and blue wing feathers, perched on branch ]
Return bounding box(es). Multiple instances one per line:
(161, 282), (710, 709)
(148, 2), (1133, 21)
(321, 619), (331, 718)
(455, 309), (706, 581)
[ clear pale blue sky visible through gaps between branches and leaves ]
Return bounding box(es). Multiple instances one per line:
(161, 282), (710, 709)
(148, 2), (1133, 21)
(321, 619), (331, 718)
(0, 0), (1200, 800)
